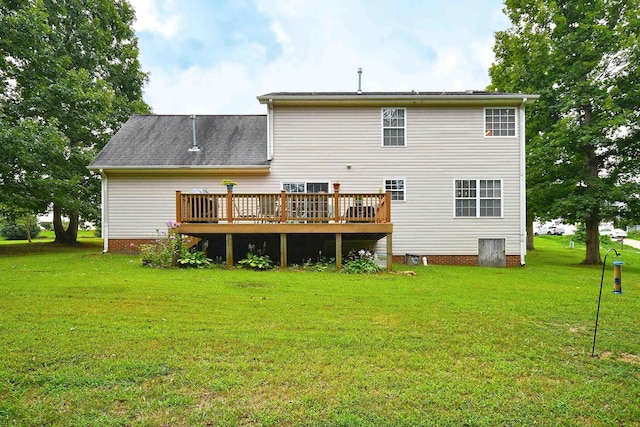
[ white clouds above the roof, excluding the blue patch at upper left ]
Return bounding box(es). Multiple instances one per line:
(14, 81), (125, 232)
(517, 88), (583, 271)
(133, 0), (508, 114)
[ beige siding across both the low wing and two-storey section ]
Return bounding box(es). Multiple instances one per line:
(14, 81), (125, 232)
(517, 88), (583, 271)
(105, 105), (521, 265)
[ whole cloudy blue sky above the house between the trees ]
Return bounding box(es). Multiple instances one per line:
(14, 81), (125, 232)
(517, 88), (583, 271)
(130, 0), (509, 114)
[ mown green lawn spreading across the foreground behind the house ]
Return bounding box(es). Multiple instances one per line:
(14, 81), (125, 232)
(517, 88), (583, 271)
(0, 236), (640, 426)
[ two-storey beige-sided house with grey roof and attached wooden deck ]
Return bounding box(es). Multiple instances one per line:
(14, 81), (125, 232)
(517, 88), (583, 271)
(89, 91), (538, 266)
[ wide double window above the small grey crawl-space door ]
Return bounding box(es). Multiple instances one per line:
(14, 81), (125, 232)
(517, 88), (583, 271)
(455, 179), (502, 217)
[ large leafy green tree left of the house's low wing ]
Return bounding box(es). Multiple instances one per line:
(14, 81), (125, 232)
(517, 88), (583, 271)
(0, 0), (149, 243)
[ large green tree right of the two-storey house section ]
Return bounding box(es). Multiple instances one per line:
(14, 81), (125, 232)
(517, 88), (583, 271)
(489, 0), (640, 264)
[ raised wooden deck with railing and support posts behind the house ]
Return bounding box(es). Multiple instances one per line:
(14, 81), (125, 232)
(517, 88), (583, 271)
(176, 191), (393, 270)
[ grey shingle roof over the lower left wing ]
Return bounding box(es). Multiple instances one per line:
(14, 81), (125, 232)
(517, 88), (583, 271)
(89, 115), (269, 169)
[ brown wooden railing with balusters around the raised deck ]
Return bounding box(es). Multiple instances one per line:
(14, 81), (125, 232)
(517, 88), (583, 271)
(176, 191), (391, 223)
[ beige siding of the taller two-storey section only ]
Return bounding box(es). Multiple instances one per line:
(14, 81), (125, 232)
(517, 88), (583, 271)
(271, 106), (521, 255)
